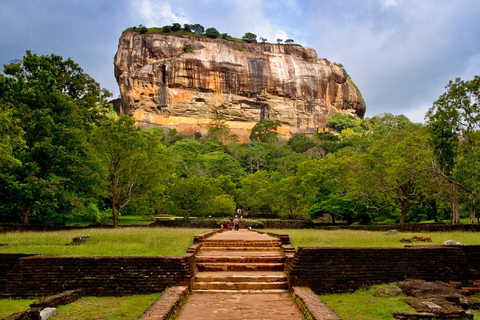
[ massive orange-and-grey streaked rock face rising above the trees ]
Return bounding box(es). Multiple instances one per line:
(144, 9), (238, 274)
(114, 31), (365, 141)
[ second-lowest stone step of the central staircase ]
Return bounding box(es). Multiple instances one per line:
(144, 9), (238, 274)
(195, 271), (287, 282)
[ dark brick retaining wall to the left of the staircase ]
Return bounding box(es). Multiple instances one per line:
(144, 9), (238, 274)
(0, 253), (196, 297)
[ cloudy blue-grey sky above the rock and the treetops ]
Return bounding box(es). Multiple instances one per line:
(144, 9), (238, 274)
(0, 0), (480, 122)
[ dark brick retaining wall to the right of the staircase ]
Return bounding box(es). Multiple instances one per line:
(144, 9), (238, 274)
(286, 246), (480, 293)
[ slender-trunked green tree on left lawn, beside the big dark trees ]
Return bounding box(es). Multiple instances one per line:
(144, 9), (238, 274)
(91, 116), (170, 227)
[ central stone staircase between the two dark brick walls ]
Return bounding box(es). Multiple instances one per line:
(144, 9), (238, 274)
(192, 230), (288, 293)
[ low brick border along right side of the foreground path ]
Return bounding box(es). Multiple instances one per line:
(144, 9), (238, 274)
(290, 287), (342, 320)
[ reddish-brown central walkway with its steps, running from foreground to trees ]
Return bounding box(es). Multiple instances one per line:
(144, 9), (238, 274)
(177, 229), (304, 320)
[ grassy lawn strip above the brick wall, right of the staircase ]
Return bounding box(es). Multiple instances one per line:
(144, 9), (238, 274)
(268, 229), (480, 249)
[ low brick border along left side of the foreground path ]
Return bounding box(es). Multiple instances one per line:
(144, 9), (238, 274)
(138, 287), (190, 320)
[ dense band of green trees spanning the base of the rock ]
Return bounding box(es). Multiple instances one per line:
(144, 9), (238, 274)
(0, 52), (480, 226)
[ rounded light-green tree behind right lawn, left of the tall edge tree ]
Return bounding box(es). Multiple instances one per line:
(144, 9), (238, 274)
(355, 124), (431, 224)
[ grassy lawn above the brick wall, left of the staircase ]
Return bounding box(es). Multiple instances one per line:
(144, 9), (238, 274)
(0, 227), (210, 256)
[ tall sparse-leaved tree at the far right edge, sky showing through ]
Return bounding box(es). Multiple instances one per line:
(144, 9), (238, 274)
(425, 76), (480, 223)
